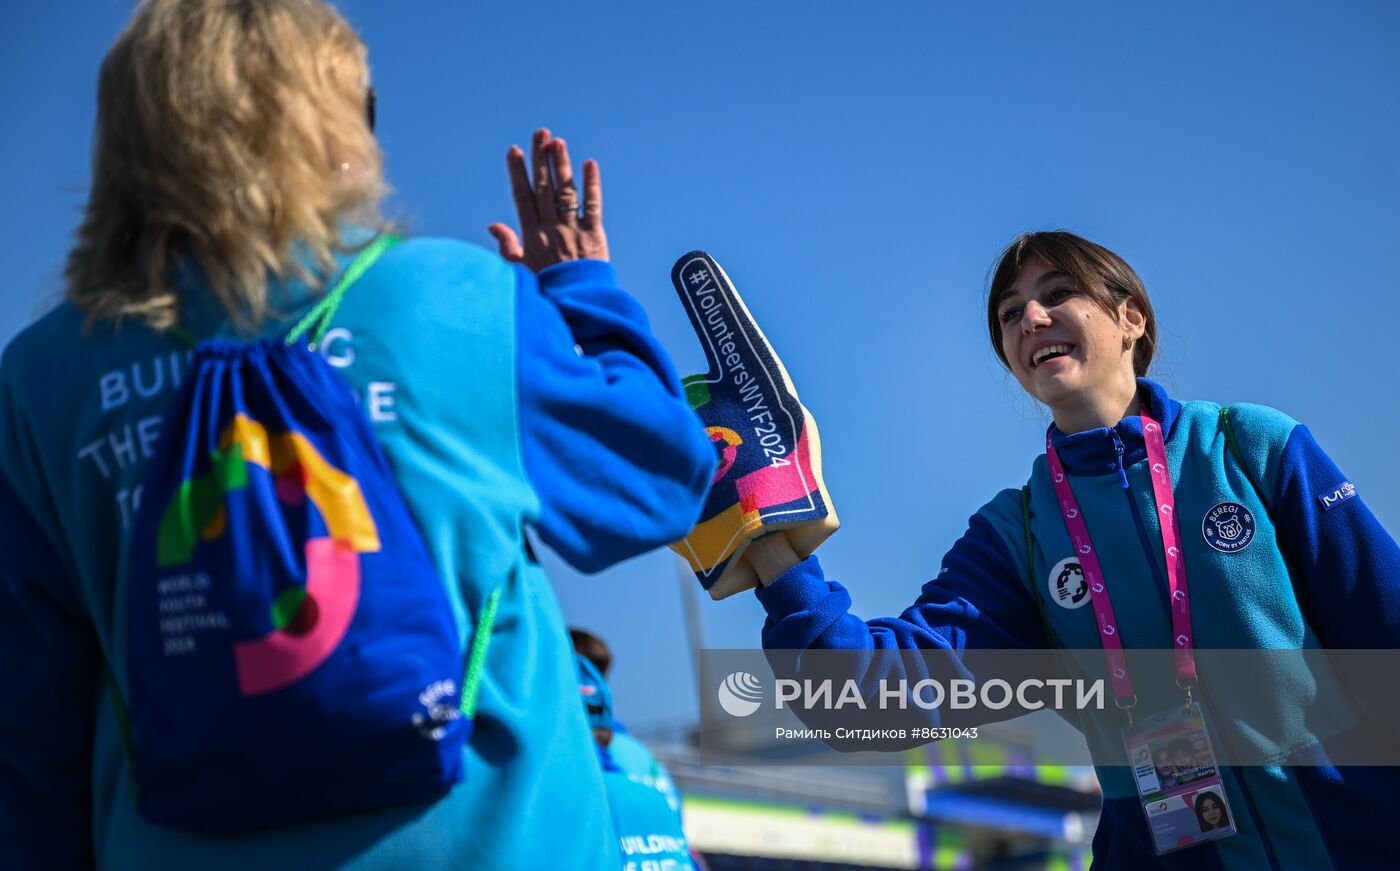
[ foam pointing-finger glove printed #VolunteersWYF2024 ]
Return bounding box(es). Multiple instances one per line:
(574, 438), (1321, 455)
(671, 251), (840, 599)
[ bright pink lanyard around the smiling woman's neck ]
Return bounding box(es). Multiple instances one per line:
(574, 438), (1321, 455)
(1046, 413), (1196, 721)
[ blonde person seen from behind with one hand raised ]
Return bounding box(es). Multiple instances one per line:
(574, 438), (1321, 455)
(0, 0), (714, 871)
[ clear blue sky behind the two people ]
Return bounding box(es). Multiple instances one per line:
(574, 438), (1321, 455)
(0, 0), (1400, 724)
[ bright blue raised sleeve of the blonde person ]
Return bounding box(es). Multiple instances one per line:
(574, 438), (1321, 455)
(517, 260), (715, 571)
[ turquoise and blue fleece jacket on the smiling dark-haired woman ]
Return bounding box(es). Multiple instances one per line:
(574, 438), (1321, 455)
(757, 379), (1400, 871)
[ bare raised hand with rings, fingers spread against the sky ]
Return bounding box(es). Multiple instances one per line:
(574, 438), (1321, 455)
(486, 127), (608, 272)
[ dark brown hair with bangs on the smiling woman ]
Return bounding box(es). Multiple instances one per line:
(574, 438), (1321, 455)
(987, 230), (1156, 375)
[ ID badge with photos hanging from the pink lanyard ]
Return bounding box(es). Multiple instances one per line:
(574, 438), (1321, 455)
(1123, 704), (1236, 856)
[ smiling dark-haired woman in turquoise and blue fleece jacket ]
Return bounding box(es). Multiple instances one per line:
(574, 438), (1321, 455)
(746, 231), (1400, 871)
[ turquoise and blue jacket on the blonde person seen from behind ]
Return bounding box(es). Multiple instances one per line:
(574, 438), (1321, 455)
(0, 239), (714, 871)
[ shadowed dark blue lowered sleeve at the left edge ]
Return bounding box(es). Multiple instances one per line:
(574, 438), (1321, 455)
(0, 476), (101, 868)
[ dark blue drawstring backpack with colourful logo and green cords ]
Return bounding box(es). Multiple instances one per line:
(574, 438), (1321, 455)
(115, 237), (498, 835)
